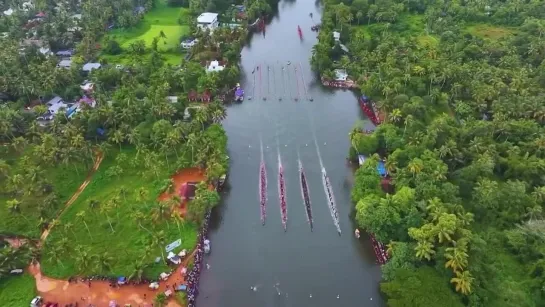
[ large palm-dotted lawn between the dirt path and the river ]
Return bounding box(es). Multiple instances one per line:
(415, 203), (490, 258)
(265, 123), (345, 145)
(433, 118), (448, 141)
(41, 148), (197, 278)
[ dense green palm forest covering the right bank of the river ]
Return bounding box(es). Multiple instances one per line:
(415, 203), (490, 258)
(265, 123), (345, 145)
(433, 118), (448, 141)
(312, 0), (545, 307)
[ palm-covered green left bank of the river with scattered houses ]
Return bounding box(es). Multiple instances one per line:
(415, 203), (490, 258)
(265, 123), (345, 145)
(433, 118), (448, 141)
(0, 0), (270, 306)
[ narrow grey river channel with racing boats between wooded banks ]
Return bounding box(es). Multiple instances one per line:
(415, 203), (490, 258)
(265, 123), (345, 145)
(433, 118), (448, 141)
(198, 0), (382, 307)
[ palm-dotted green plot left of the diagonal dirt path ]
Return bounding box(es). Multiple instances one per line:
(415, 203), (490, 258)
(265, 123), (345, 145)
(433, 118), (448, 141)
(0, 146), (92, 238)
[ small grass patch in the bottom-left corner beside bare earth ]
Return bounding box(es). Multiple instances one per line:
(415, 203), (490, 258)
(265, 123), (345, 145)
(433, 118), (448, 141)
(0, 273), (36, 307)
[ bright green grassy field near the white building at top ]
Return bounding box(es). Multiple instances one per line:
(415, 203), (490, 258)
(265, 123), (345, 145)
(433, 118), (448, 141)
(108, 0), (190, 51)
